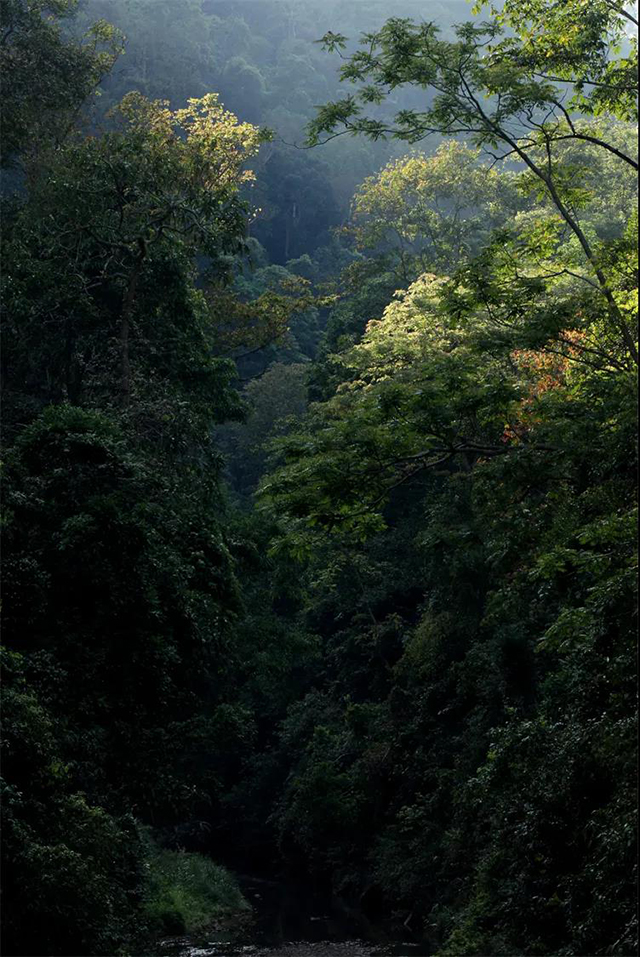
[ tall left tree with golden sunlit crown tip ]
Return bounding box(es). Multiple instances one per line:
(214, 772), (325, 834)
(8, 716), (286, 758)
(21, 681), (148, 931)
(4, 94), (262, 442)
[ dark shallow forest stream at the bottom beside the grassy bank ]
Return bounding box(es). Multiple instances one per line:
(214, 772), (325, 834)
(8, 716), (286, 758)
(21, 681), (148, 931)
(160, 878), (429, 957)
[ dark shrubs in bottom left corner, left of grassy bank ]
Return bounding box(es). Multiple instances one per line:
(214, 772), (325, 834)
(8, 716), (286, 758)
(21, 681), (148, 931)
(2, 651), (143, 957)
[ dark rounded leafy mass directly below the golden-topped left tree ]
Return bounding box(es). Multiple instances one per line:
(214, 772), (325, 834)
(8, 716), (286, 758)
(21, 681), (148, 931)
(4, 406), (236, 820)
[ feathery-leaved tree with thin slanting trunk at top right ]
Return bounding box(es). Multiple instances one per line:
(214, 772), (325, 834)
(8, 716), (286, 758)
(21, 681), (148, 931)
(309, 0), (638, 364)
